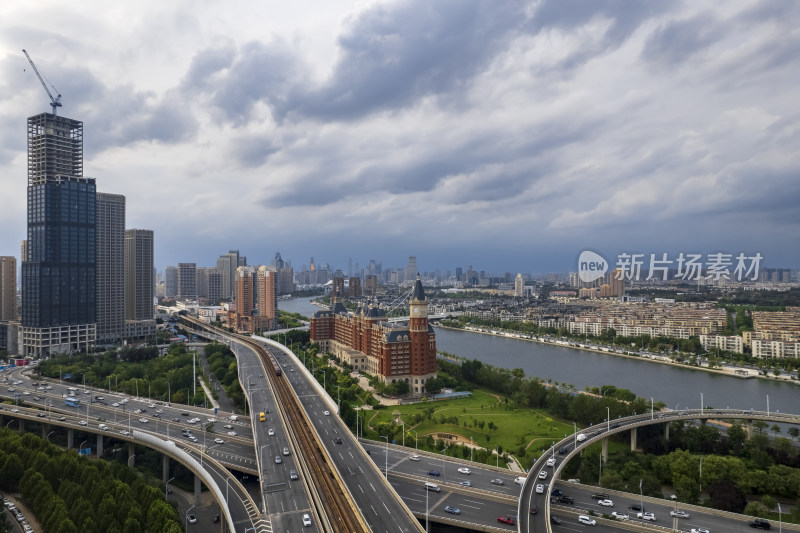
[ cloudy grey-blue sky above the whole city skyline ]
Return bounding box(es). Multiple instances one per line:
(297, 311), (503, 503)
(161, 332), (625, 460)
(0, 0), (800, 273)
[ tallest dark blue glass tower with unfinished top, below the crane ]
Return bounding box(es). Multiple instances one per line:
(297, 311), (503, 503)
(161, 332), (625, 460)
(22, 113), (97, 357)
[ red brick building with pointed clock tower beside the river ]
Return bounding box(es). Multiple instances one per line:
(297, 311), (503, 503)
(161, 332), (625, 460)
(311, 276), (436, 395)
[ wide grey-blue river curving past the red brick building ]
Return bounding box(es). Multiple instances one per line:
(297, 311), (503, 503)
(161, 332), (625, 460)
(278, 298), (800, 413)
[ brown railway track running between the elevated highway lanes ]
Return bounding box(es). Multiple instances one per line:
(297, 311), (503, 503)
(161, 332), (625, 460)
(182, 316), (369, 533)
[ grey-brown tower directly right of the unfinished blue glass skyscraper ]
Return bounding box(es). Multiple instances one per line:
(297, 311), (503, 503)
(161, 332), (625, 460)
(97, 192), (125, 343)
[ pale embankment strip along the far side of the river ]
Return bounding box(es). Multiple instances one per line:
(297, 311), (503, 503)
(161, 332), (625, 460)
(433, 323), (800, 384)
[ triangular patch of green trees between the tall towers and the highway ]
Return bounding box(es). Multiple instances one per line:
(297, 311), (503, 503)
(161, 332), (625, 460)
(36, 343), (205, 405)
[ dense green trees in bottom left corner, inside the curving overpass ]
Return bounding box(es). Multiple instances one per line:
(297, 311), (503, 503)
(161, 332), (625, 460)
(0, 430), (183, 533)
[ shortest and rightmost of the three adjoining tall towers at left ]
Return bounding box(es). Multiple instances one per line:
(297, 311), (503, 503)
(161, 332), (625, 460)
(125, 229), (153, 320)
